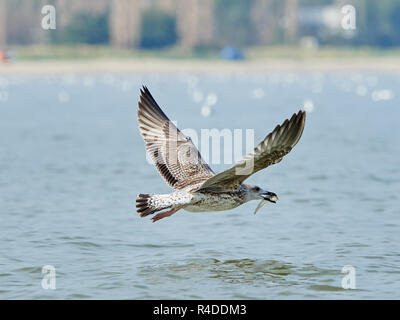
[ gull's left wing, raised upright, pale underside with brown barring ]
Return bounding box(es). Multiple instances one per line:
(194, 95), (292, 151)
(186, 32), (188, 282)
(138, 87), (214, 189)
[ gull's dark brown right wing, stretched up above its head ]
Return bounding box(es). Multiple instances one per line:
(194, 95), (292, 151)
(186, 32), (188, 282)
(199, 110), (306, 191)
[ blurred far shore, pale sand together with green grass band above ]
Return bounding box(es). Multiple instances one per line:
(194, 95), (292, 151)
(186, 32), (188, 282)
(0, 45), (400, 74)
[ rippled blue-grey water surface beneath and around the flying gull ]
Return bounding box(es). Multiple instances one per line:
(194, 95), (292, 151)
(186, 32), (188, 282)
(0, 72), (400, 299)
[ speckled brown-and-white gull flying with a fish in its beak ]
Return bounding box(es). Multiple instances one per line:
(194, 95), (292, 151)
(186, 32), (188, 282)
(136, 86), (306, 222)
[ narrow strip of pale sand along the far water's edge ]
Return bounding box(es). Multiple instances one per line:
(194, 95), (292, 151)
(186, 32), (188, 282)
(0, 58), (400, 74)
